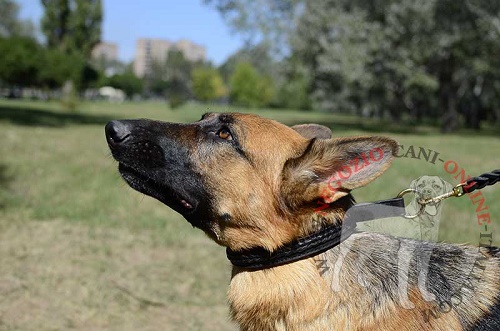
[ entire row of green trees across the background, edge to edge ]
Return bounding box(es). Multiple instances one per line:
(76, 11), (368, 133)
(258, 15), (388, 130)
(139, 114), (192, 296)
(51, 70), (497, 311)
(0, 0), (500, 132)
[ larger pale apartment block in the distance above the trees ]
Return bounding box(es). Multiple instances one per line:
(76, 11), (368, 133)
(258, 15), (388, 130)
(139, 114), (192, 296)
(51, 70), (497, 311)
(134, 38), (206, 77)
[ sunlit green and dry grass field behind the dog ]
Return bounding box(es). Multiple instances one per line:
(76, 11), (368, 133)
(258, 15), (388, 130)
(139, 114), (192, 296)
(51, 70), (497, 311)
(0, 100), (500, 331)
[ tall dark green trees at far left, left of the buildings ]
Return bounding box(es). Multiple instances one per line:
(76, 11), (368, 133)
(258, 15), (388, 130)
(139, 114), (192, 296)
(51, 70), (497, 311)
(0, 0), (102, 97)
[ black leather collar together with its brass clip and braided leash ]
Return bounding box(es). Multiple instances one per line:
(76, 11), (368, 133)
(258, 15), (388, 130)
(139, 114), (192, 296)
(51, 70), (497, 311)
(226, 169), (500, 270)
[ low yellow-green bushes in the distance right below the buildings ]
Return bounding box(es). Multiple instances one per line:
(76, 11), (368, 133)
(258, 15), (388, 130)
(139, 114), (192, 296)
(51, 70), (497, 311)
(144, 50), (273, 108)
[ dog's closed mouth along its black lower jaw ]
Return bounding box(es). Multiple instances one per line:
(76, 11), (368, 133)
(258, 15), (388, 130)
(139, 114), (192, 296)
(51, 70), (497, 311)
(118, 162), (198, 215)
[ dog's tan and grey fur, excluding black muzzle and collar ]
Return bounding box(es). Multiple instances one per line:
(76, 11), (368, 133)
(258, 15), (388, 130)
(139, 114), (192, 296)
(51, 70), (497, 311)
(107, 114), (500, 331)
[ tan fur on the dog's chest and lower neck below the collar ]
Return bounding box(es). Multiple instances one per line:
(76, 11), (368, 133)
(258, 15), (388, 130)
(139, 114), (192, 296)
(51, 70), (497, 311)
(229, 259), (461, 331)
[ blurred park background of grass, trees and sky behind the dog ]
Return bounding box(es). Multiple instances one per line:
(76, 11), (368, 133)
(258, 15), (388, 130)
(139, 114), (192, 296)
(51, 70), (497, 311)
(0, 0), (500, 330)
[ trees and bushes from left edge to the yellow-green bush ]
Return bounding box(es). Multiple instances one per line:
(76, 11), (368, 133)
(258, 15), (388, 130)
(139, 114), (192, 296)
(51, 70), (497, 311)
(0, 0), (304, 108)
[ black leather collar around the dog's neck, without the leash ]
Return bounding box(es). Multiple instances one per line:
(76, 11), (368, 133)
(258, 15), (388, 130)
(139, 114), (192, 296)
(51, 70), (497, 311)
(226, 198), (405, 269)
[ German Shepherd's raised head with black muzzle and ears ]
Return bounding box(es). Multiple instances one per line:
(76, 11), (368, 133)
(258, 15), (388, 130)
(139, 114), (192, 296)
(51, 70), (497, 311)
(106, 113), (397, 250)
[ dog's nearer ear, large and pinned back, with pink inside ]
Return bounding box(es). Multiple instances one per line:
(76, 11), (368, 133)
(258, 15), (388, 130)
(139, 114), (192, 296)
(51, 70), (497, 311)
(281, 137), (398, 206)
